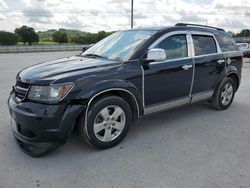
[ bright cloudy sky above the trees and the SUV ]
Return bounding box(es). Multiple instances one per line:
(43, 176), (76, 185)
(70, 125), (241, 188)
(0, 0), (250, 32)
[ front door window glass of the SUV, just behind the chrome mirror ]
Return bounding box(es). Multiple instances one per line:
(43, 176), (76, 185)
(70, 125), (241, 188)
(155, 34), (188, 59)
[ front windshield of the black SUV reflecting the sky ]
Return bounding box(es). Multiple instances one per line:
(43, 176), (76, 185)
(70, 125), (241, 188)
(81, 30), (155, 60)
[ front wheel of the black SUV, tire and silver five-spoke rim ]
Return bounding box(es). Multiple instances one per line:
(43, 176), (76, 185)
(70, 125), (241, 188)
(79, 96), (132, 149)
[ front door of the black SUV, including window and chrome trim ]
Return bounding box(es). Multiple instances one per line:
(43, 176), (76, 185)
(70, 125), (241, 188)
(143, 31), (194, 114)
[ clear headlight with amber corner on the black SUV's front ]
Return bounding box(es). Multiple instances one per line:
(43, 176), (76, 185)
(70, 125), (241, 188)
(28, 83), (73, 102)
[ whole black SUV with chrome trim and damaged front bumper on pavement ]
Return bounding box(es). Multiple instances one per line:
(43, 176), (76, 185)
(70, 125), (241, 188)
(8, 23), (243, 156)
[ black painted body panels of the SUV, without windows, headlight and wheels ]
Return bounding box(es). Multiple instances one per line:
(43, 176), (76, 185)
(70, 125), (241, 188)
(8, 26), (242, 143)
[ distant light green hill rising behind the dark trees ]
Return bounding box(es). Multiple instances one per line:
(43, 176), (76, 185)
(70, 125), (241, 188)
(37, 29), (88, 41)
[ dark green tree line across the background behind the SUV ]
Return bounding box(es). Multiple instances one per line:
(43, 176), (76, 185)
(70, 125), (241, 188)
(0, 26), (250, 45)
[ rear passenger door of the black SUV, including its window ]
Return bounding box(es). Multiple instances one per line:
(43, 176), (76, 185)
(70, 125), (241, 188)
(191, 31), (225, 101)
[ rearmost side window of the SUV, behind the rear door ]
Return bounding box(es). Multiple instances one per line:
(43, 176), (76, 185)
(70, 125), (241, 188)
(215, 33), (238, 52)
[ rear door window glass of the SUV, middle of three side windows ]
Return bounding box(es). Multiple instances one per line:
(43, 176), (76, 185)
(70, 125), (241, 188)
(192, 35), (217, 56)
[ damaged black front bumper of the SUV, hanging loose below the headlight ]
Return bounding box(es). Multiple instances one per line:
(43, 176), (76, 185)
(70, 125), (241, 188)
(8, 96), (85, 145)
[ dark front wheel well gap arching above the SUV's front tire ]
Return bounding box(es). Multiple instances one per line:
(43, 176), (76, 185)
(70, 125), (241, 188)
(87, 90), (140, 121)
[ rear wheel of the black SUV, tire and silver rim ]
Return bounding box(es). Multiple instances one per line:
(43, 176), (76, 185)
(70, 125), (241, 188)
(212, 77), (236, 110)
